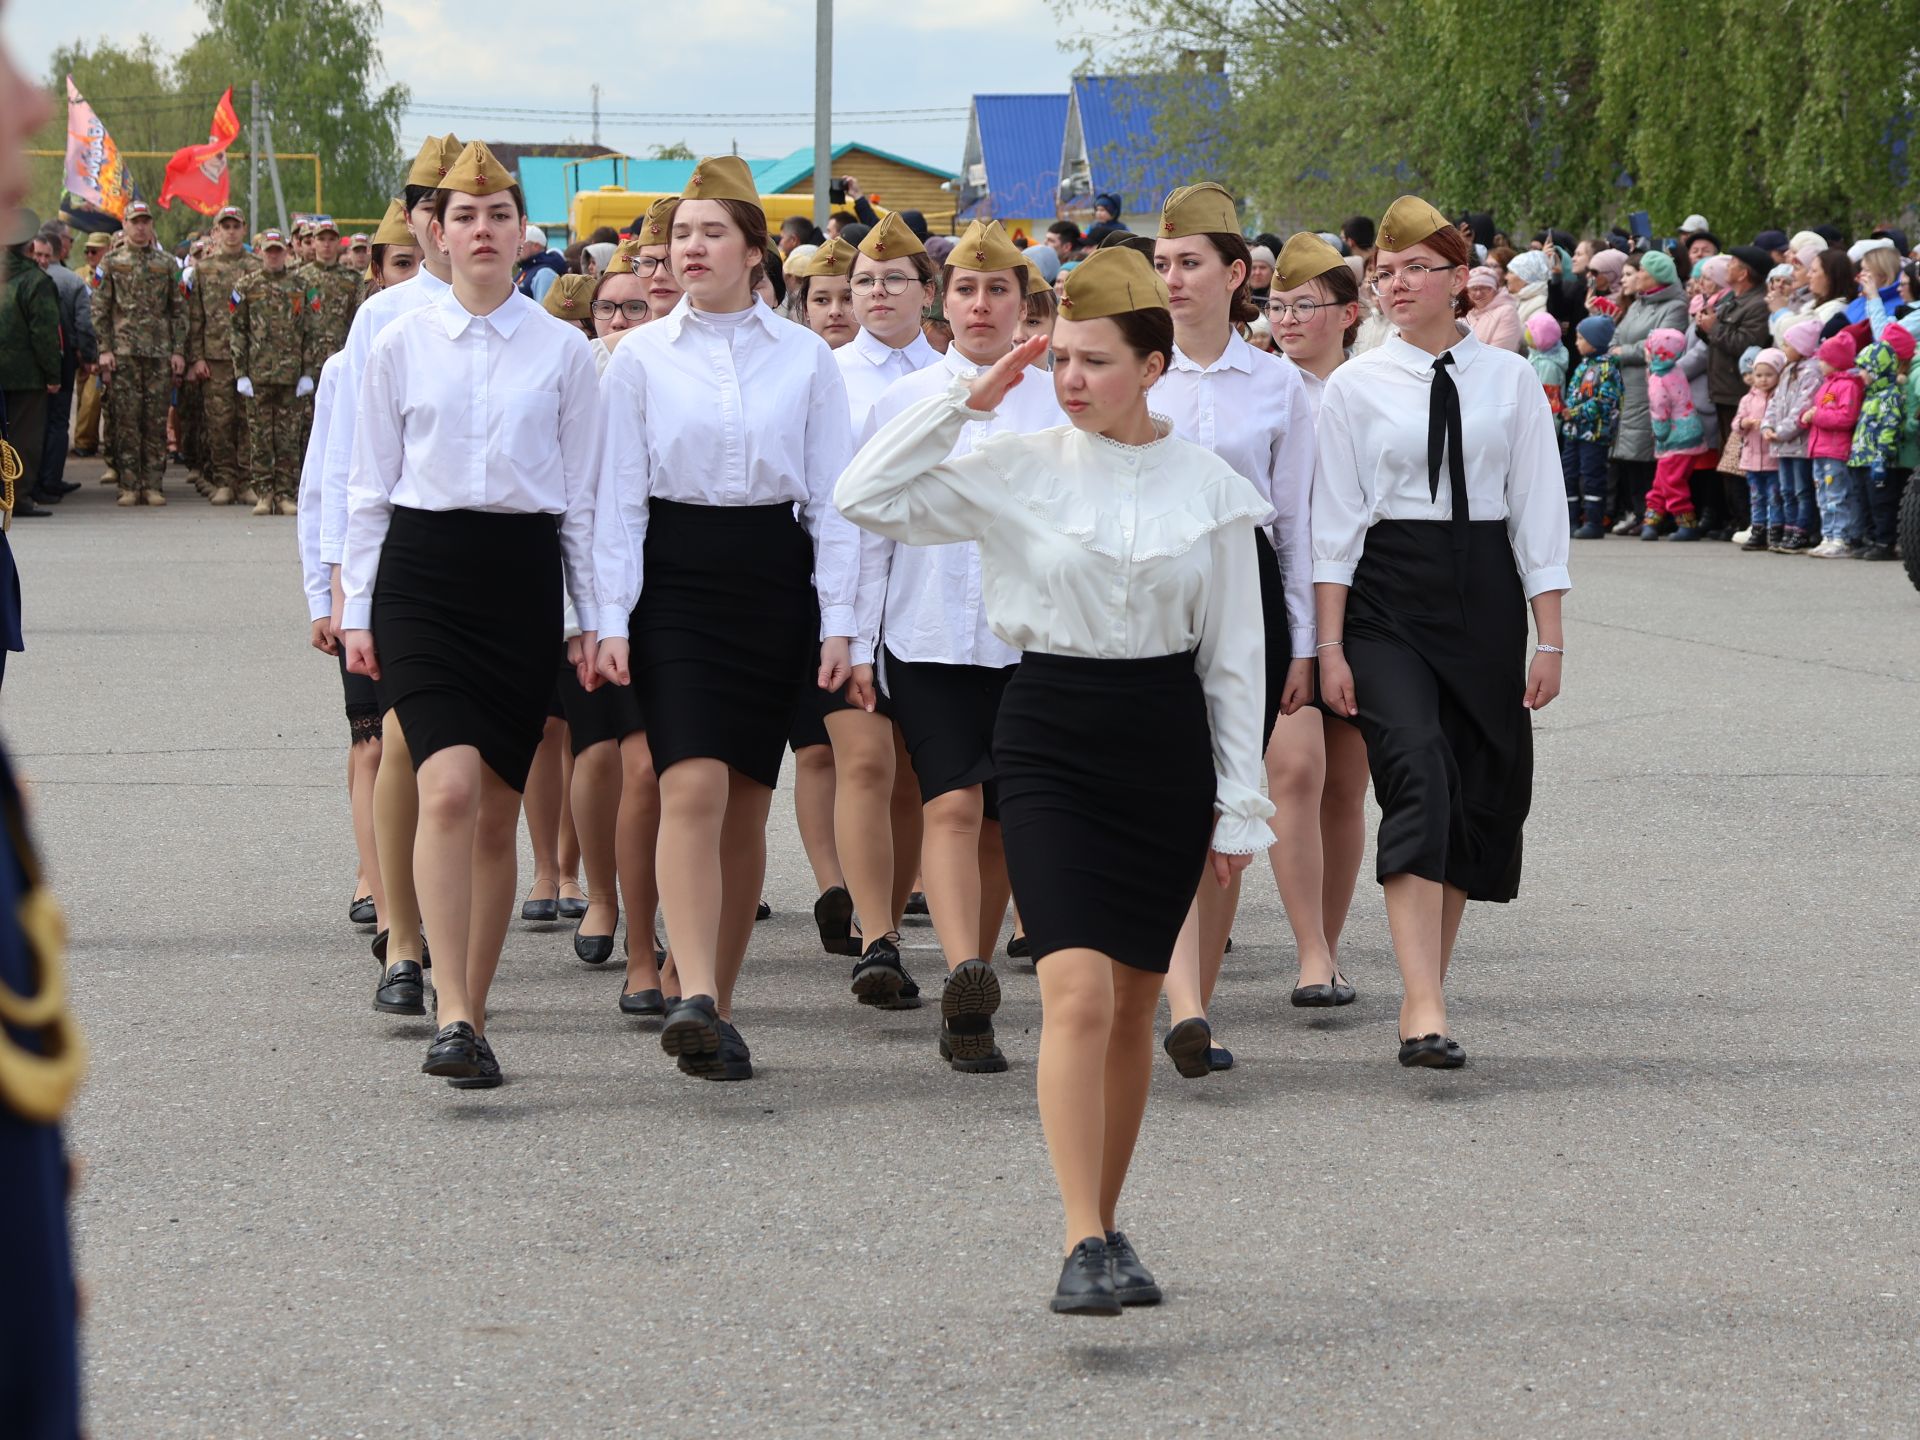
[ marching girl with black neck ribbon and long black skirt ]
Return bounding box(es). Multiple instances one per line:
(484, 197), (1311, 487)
(1313, 196), (1569, 1069)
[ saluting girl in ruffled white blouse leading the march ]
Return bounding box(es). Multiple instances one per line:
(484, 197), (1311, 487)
(837, 242), (1273, 1315)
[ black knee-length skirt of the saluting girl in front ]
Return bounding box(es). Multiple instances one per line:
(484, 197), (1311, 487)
(993, 651), (1215, 975)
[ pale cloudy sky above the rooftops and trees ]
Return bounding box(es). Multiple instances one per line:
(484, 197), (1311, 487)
(4, 0), (1116, 171)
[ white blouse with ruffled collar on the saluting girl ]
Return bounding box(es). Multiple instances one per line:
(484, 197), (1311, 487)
(833, 376), (1273, 854)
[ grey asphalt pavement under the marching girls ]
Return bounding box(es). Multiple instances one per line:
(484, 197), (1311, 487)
(15, 463), (1920, 1440)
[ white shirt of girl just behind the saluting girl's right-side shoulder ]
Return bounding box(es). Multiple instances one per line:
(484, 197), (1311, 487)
(1152, 330), (1313, 660)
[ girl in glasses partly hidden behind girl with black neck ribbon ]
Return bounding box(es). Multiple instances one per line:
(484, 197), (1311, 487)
(1267, 230), (1367, 1010)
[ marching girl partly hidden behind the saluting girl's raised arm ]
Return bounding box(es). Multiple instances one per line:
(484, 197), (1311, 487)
(852, 221), (1062, 1073)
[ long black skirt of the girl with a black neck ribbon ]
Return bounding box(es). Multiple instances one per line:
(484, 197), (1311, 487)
(1344, 520), (1534, 902)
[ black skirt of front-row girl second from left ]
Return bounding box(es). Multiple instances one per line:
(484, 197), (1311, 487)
(630, 499), (818, 787)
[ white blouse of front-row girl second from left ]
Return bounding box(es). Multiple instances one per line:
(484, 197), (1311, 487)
(593, 296), (860, 639)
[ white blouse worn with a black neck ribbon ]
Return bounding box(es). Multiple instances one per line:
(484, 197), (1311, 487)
(1313, 334), (1572, 599)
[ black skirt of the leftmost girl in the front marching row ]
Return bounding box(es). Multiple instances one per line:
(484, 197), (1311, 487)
(372, 507), (563, 791)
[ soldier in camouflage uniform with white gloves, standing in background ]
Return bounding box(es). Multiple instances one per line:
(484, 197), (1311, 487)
(232, 230), (321, 515)
